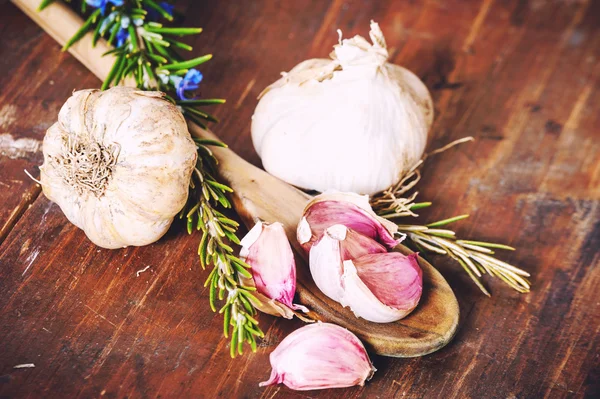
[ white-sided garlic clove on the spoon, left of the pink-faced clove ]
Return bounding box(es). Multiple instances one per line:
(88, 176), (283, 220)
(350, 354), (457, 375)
(308, 224), (387, 302)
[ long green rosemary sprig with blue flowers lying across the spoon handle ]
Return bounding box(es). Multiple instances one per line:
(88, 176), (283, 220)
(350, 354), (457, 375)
(45, 0), (264, 357)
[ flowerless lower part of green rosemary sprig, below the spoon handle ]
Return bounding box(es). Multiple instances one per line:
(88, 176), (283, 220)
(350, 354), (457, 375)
(180, 139), (264, 357)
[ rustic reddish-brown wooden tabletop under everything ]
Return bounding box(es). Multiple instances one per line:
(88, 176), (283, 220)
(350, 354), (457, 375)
(0, 0), (600, 398)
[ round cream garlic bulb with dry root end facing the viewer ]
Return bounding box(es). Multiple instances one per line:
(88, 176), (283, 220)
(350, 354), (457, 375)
(40, 87), (197, 248)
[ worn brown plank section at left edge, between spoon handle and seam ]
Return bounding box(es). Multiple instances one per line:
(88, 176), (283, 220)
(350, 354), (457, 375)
(0, 2), (96, 243)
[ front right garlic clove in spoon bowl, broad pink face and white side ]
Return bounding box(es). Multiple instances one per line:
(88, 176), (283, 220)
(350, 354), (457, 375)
(340, 252), (423, 323)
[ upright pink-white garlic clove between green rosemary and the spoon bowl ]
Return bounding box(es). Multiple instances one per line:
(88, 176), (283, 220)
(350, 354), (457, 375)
(240, 221), (308, 318)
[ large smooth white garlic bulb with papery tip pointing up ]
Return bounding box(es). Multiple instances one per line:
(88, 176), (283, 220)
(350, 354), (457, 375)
(252, 22), (433, 194)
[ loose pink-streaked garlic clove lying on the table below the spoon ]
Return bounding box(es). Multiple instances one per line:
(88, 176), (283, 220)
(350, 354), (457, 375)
(259, 323), (376, 391)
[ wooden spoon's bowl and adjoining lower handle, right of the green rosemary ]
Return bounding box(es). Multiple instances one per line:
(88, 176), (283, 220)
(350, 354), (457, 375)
(188, 123), (459, 357)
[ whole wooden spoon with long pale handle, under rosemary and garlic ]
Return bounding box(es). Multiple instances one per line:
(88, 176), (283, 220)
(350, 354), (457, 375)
(12, 0), (459, 357)
